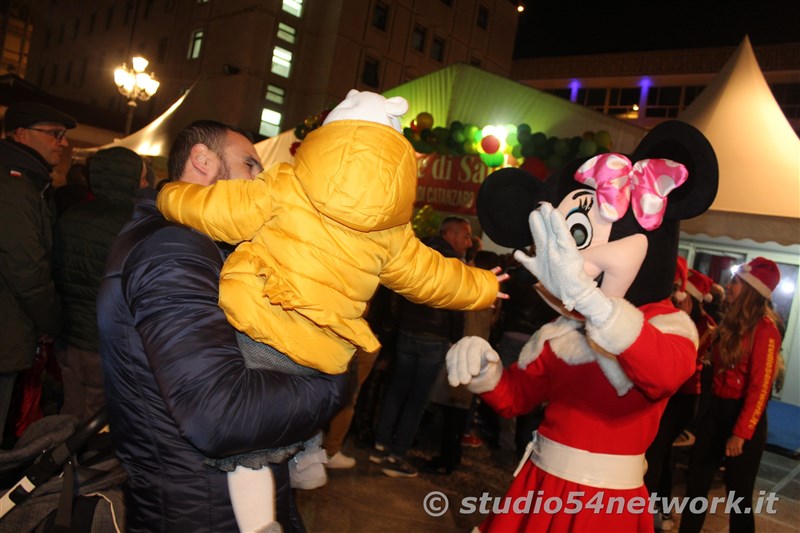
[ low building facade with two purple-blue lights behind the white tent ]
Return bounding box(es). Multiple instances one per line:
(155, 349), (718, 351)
(511, 42), (800, 131)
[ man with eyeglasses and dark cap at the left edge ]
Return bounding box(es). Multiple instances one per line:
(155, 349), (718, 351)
(0, 102), (77, 440)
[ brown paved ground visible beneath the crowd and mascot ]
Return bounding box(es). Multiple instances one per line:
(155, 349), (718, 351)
(297, 422), (800, 533)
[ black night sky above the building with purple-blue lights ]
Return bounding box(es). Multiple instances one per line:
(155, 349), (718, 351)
(514, 0), (800, 58)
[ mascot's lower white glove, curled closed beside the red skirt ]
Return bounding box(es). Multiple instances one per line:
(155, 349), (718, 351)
(447, 337), (503, 394)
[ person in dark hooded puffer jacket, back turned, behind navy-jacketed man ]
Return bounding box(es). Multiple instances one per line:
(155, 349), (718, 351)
(53, 146), (145, 421)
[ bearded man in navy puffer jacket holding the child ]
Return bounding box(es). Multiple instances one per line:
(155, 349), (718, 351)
(97, 121), (346, 533)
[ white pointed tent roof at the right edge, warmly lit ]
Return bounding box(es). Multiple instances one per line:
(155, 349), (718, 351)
(678, 37), (800, 244)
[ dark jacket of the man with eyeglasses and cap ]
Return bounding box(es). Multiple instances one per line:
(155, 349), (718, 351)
(0, 140), (61, 373)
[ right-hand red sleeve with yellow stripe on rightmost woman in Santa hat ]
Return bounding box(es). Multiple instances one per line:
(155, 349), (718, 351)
(733, 319), (781, 440)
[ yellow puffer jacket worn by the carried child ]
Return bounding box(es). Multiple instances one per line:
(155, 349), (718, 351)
(158, 120), (498, 374)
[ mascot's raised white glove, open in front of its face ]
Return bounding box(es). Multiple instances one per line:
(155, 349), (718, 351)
(514, 202), (613, 326)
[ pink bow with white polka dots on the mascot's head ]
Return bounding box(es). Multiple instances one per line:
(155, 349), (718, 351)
(575, 153), (689, 231)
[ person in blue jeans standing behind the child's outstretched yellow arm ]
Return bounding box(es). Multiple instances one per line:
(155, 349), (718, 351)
(369, 217), (472, 477)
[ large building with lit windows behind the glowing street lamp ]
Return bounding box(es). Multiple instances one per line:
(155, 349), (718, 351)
(23, 0), (518, 137)
